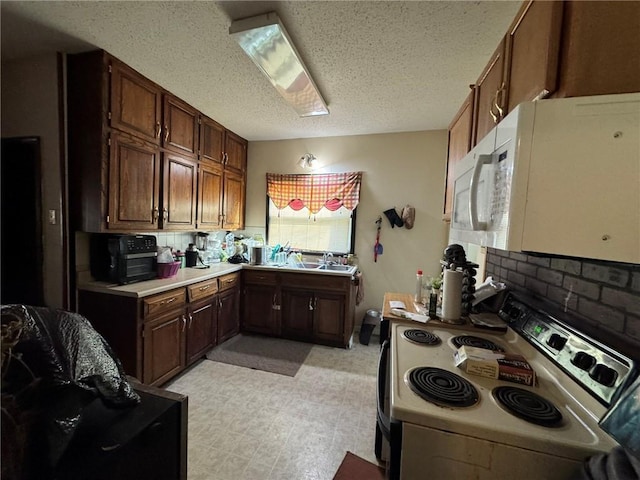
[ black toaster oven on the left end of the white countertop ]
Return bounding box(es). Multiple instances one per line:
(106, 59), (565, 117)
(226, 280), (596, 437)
(90, 234), (158, 285)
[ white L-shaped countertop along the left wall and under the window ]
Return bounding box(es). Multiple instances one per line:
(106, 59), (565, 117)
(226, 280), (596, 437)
(78, 262), (358, 298)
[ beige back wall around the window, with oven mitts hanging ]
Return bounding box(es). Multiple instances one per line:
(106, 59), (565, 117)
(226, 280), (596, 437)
(246, 130), (448, 320)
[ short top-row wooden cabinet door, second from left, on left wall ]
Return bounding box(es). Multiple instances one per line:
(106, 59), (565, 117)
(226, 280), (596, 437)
(162, 94), (198, 157)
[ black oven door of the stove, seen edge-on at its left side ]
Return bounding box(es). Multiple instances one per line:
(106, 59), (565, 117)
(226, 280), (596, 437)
(375, 339), (402, 480)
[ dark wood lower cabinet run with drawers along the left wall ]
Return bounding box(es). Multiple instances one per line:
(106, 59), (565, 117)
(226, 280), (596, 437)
(78, 273), (240, 386)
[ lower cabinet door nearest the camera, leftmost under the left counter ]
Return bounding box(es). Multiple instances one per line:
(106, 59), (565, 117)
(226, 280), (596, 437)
(143, 311), (187, 385)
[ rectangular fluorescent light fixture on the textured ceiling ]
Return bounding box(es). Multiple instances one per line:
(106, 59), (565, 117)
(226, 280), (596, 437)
(229, 12), (329, 117)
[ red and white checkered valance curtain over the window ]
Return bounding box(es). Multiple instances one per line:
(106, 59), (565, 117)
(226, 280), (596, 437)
(267, 172), (362, 214)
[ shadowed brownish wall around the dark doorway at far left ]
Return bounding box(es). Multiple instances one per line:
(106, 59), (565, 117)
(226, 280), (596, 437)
(2, 54), (64, 308)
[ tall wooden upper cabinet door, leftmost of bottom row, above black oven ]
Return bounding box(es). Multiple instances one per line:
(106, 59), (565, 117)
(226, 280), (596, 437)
(107, 134), (160, 232)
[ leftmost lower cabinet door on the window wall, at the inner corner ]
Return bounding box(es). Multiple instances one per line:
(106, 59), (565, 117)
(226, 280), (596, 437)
(242, 285), (280, 335)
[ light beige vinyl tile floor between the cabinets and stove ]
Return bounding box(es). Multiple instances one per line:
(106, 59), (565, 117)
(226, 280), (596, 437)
(166, 337), (380, 480)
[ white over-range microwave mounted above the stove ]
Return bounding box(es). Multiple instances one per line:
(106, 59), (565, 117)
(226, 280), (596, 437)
(449, 93), (640, 263)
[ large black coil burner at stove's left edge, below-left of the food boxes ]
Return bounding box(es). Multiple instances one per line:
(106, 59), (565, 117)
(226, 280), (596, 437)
(408, 367), (480, 407)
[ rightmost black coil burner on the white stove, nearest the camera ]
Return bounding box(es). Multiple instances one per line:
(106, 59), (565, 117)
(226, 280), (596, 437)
(491, 387), (562, 427)
